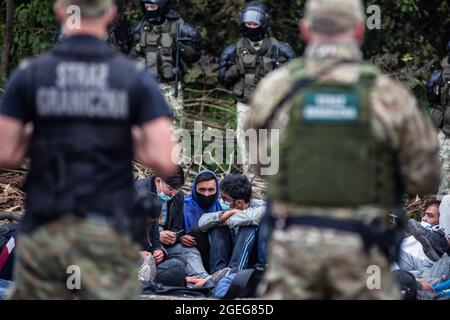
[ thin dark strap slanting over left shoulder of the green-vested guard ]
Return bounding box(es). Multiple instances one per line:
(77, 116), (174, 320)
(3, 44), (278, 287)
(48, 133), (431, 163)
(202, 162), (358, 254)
(260, 59), (355, 129)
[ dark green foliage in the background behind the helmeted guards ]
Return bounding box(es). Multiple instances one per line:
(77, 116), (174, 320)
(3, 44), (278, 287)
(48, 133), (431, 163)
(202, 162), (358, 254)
(0, 0), (450, 96)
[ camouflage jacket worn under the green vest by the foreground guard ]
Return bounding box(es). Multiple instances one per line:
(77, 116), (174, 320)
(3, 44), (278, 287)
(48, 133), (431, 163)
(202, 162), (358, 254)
(246, 43), (440, 218)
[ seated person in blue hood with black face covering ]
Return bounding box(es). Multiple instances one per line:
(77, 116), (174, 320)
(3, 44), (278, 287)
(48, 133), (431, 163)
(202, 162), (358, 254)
(180, 170), (223, 265)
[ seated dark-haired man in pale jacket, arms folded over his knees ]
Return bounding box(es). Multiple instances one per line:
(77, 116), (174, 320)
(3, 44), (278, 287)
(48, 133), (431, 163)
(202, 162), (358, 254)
(198, 174), (266, 273)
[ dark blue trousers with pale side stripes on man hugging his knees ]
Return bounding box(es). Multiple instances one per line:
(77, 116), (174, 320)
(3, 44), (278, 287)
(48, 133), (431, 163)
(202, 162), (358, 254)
(209, 226), (258, 274)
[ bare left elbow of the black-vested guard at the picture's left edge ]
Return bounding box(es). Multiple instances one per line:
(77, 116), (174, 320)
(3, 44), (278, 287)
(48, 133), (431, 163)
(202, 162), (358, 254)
(0, 116), (33, 167)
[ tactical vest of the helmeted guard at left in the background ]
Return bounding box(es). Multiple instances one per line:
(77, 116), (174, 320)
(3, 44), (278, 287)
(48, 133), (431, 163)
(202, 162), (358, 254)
(139, 18), (184, 81)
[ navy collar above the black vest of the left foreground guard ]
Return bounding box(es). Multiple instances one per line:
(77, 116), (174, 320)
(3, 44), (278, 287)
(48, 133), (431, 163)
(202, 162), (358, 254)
(53, 34), (115, 56)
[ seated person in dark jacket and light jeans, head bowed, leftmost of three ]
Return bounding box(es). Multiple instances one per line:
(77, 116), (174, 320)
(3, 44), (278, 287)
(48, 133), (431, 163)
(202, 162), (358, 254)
(135, 167), (209, 278)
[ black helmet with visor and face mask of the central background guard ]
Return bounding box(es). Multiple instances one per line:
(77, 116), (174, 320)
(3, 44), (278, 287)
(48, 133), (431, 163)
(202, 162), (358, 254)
(239, 1), (269, 41)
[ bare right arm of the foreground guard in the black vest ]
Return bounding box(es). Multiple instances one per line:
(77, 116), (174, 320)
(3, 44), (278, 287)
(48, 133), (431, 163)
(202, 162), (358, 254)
(133, 117), (178, 175)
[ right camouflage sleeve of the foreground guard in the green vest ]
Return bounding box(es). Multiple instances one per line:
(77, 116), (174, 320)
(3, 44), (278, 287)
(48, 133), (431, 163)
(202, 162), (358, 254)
(371, 76), (440, 195)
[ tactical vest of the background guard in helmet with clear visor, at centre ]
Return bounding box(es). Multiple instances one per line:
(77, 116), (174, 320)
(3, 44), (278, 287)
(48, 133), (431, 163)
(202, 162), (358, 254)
(233, 38), (280, 103)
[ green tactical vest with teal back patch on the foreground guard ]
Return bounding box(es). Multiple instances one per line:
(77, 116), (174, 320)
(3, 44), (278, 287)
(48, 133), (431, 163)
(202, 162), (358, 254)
(270, 60), (401, 210)
